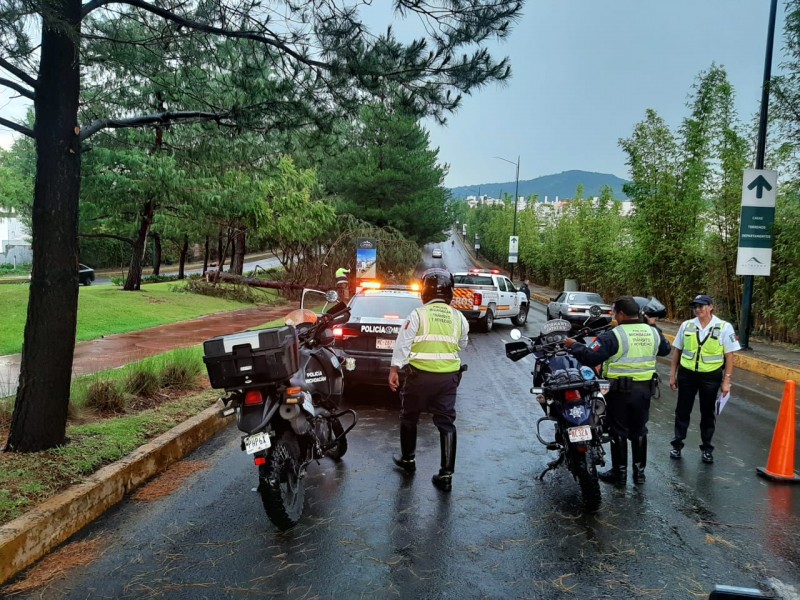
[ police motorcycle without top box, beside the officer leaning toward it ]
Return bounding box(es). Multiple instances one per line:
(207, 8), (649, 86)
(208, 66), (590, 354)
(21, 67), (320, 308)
(506, 306), (611, 512)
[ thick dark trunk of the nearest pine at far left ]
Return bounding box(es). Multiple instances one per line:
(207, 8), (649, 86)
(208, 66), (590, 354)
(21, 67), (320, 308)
(5, 0), (81, 452)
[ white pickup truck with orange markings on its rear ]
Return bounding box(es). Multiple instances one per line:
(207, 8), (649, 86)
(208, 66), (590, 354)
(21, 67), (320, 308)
(450, 269), (528, 332)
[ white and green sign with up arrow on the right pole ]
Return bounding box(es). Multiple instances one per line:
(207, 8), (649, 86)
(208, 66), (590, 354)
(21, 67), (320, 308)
(736, 169), (778, 276)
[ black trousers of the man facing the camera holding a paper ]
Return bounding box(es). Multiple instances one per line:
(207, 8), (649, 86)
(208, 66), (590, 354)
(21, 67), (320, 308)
(672, 365), (725, 452)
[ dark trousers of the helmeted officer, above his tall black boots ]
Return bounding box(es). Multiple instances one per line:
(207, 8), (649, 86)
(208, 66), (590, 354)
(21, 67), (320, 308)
(400, 367), (461, 433)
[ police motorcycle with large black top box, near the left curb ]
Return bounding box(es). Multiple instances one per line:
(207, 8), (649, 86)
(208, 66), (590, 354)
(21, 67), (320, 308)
(203, 289), (358, 530)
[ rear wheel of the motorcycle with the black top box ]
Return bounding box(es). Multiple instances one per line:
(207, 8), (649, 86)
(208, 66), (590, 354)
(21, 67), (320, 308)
(258, 431), (305, 531)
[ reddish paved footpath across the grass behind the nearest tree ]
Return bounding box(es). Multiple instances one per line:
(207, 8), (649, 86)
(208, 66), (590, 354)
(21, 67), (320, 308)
(0, 304), (295, 395)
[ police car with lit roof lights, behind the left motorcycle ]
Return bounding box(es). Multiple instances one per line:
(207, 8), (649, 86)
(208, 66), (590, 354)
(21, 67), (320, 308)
(333, 286), (422, 387)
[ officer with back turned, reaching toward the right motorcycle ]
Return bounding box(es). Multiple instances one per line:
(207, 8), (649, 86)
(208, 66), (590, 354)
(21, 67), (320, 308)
(565, 296), (671, 485)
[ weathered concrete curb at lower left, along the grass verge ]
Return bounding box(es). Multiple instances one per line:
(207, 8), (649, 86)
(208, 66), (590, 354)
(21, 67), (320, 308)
(0, 406), (232, 584)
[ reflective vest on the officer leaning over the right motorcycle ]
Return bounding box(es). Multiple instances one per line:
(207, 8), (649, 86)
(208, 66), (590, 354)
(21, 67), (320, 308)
(603, 323), (661, 381)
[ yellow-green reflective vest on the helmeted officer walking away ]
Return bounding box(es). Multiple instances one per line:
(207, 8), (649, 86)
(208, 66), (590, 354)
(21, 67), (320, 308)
(408, 302), (462, 373)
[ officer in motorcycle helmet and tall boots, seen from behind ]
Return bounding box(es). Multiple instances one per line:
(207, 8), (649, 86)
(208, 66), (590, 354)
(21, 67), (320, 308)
(389, 269), (469, 492)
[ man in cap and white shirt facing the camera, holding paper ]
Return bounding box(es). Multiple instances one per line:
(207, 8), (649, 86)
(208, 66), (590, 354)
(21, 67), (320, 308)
(669, 294), (741, 463)
